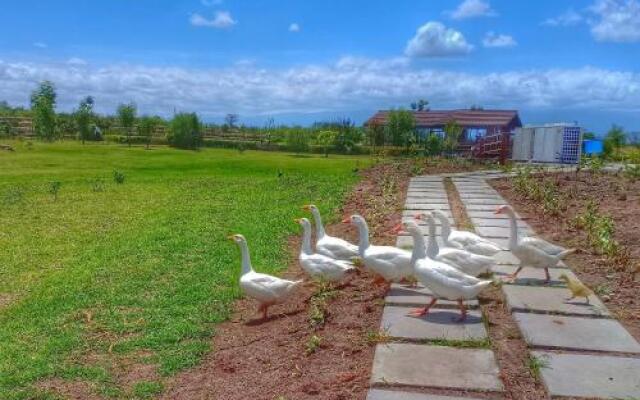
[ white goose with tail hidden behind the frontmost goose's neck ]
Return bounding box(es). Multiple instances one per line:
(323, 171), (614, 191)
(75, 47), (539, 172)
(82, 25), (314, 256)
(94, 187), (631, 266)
(342, 214), (413, 282)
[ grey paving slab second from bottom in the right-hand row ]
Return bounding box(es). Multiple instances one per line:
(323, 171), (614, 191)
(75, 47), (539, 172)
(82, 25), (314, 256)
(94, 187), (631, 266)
(513, 313), (640, 354)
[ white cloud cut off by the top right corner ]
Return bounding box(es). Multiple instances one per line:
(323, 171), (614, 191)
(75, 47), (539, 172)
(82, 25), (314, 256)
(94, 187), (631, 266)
(589, 0), (640, 42)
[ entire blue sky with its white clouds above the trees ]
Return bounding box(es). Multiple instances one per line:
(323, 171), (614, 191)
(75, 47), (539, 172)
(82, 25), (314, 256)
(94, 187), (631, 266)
(0, 0), (640, 132)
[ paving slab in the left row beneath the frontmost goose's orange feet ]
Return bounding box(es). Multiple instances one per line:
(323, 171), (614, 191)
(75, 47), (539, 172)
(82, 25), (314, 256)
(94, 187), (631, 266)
(380, 304), (487, 341)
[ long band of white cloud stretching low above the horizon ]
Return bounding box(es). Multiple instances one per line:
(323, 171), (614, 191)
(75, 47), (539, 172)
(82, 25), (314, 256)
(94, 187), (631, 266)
(0, 57), (640, 118)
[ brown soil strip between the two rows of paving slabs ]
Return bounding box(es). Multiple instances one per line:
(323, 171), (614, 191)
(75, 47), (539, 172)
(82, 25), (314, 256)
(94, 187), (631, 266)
(444, 179), (549, 400)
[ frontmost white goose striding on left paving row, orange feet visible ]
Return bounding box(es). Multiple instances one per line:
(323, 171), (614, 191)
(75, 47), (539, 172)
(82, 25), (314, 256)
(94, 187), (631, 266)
(405, 222), (491, 322)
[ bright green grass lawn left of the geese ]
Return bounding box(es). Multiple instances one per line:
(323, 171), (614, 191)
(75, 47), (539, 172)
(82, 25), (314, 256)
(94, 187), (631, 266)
(0, 141), (369, 399)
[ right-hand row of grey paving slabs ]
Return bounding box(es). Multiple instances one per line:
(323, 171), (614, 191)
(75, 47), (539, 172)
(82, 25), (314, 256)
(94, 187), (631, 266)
(453, 173), (640, 399)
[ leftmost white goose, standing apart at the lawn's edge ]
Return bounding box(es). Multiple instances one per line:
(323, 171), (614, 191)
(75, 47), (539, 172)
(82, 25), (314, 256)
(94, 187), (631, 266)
(229, 235), (302, 319)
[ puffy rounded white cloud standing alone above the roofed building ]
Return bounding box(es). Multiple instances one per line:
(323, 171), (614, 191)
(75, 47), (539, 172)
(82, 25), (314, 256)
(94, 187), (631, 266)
(405, 21), (473, 57)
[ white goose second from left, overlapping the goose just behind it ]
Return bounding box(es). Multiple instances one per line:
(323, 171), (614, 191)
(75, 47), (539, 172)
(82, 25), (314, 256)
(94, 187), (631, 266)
(295, 218), (355, 282)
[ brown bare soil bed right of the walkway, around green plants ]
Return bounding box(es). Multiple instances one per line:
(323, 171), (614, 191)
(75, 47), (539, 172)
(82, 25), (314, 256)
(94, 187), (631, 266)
(492, 172), (640, 340)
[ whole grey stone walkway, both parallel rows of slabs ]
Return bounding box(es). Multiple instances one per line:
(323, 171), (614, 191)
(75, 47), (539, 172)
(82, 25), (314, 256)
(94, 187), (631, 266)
(367, 171), (640, 400)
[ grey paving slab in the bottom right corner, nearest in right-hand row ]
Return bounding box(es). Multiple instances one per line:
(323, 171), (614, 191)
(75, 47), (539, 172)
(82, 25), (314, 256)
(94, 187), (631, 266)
(533, 351), (640, 399)
